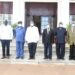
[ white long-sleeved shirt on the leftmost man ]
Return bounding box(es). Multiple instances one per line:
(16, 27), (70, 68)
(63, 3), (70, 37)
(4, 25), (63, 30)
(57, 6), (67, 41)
(0, 25), (13, 40)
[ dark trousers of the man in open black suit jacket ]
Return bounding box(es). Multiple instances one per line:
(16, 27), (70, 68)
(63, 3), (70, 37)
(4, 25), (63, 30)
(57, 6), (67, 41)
(44, 43), (52, 59)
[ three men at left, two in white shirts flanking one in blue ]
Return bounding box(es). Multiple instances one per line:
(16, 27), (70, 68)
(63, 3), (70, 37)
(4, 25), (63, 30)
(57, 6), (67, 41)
(0, 20), (39, 59)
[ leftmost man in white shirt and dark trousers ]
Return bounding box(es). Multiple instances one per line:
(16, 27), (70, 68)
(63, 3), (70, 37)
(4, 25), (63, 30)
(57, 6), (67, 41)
(0, 20), (13, 59)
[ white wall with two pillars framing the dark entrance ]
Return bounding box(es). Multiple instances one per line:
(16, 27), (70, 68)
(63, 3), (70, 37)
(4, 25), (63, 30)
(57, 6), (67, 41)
(0, 0), (72, 27)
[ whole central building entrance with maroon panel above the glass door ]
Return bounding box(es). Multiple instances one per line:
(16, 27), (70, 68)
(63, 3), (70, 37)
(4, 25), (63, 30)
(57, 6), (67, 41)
(25, 2), (57, 34)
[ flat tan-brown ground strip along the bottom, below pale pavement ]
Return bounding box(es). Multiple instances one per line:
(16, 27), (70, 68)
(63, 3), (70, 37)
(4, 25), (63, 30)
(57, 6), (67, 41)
(0, 64), (75, 75)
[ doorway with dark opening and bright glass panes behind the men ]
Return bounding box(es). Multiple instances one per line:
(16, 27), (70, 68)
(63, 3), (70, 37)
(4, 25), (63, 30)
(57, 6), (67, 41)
(33, 16), (56, 34)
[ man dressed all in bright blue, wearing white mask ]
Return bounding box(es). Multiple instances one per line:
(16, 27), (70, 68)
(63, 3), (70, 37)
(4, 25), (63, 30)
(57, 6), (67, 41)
(16, 21), (25, 59)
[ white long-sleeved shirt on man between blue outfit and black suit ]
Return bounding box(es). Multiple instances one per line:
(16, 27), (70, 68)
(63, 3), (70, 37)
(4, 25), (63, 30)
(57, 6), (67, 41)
(25, 26), (39, 43)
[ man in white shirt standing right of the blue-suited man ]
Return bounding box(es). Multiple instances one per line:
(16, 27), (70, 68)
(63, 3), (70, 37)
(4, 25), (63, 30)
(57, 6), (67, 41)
(25, 21), (39, 59)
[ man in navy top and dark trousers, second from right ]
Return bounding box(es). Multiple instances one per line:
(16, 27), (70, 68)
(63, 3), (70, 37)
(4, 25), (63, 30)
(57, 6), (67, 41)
(55, 22), (67, 59)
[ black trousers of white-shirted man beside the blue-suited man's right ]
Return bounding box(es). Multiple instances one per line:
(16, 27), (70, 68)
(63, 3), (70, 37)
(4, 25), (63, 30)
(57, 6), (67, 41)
(28, 43), (37, 59)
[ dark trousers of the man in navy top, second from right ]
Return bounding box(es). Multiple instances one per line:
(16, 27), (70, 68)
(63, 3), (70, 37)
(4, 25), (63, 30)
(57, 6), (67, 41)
(56, 43), (65, 59)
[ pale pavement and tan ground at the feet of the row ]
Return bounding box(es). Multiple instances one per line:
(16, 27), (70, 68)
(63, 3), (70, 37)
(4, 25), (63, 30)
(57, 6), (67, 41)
(0, 51), (75, 75)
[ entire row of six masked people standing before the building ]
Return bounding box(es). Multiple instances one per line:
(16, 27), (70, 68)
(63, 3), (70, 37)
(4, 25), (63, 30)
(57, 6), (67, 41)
(0, 20), (75, 60)
